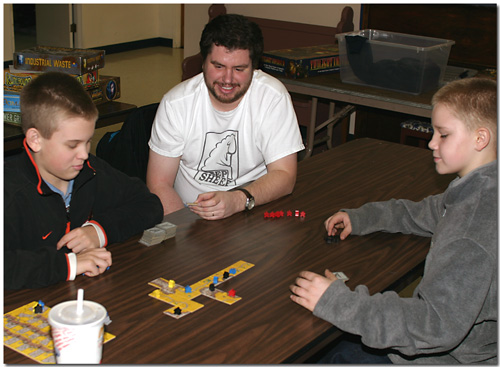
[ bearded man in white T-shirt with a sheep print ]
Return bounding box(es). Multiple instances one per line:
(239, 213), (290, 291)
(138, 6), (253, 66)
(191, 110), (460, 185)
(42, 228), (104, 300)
(147, 14), (304, 220)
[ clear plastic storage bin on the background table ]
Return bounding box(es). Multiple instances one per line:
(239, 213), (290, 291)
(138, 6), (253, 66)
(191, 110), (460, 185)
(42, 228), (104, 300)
(336, 29), (455, 94)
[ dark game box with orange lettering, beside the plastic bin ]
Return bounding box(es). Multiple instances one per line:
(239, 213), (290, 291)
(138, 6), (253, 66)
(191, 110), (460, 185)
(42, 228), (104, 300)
(260, 45), (340, 79)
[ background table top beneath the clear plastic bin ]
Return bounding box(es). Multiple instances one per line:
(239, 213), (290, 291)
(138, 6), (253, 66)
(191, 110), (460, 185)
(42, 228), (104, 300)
(278, 73), (436, 118)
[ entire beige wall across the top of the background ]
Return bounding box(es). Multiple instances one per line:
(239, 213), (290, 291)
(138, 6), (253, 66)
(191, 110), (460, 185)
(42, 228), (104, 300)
(4, 3), (361, 61)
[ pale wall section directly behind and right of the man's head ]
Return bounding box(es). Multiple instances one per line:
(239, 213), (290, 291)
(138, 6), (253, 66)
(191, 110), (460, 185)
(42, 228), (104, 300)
(184, 3), (361, 57)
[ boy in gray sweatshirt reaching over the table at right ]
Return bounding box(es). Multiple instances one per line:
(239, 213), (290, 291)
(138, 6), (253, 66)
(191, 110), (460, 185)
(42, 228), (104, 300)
(290, 78), (498, 364)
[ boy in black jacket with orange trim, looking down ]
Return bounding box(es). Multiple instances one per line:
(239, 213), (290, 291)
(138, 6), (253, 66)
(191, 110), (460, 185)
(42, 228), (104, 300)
(4, 72), (163, 289)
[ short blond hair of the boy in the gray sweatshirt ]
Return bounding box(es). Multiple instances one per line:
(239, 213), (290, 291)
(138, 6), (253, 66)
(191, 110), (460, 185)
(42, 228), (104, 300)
(432, 78), (497, 147)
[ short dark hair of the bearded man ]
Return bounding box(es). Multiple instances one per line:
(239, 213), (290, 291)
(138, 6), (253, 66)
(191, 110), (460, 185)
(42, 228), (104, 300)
(200, 14), (264, 69)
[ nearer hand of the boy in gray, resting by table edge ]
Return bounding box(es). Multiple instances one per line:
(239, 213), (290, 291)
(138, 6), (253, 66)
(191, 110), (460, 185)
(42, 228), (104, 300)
(290, 270), (337, 311)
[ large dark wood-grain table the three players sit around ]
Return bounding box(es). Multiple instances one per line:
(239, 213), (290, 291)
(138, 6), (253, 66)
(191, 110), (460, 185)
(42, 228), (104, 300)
(4, 139), (453, 364)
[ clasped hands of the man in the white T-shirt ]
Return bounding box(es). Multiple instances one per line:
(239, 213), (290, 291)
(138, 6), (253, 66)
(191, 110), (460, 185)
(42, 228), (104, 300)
(190, 191), (247, 220)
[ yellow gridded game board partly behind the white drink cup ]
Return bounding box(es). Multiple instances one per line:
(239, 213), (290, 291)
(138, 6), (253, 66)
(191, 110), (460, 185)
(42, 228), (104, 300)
(3, 301), (115, 364)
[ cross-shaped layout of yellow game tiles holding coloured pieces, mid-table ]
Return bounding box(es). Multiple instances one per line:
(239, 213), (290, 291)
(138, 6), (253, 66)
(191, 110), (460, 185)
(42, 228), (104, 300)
(148, 261), (254, 319)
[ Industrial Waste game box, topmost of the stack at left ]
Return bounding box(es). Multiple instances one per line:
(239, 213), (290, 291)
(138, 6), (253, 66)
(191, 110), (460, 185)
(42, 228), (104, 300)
(14, 46), (104, 75)
